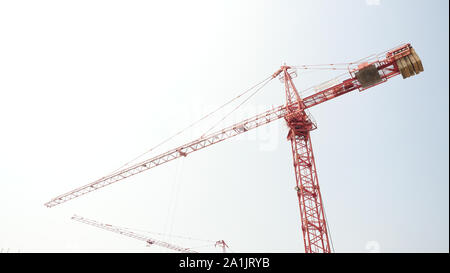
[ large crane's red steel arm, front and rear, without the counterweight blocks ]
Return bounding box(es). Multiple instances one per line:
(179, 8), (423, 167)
(45, 44), (410, 207)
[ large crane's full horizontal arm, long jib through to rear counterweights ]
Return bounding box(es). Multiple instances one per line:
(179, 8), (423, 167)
(45, 44), (423, 207)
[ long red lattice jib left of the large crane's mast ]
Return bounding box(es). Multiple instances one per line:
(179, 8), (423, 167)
(45, 106), (286, 207)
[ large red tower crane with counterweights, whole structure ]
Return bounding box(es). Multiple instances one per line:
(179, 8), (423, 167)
(45, 44), (423, 253)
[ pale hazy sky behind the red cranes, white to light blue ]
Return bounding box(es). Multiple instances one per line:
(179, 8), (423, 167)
(0, 0), (449, 252)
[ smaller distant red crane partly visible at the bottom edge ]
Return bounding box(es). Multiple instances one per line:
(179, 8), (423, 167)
(71, 215), (228, 253)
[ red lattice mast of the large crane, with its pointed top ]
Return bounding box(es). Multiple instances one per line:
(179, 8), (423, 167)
(281, 66), (331, 253)
